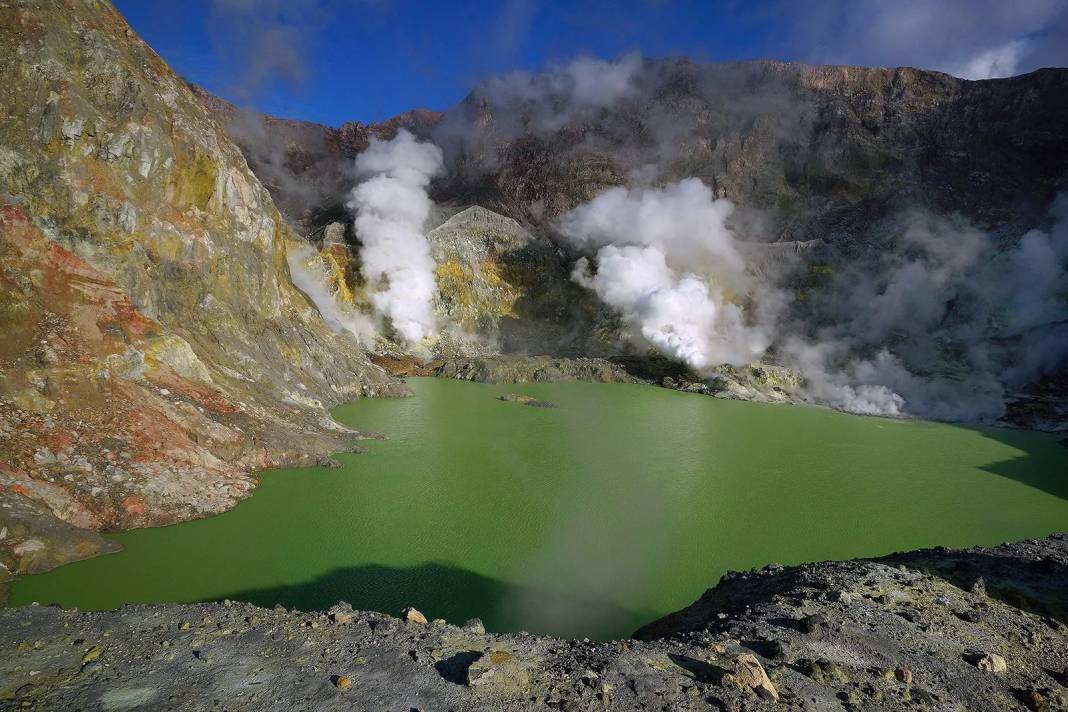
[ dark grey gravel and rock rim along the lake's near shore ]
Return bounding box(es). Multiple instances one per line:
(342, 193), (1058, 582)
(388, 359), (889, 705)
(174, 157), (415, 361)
(0, 534), (1068, 712)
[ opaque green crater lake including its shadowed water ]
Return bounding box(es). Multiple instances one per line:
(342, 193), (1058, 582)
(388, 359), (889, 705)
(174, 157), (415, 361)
(12, 379), (1068, 638)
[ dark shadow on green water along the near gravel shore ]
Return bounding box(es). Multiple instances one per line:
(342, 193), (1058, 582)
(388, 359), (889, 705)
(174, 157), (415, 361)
(211, 563), (654, 639)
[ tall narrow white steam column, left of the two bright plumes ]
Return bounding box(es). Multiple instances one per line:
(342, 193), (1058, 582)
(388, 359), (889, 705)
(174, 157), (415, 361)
(347, 129), (444, 344)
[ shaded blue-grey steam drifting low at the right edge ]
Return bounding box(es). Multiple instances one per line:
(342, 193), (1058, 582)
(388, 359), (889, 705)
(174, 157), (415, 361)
(798, 197), (1068, 421)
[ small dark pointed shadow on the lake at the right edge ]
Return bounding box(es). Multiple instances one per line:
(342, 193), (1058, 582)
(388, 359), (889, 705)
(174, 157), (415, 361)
(969, 428), (1068, 503)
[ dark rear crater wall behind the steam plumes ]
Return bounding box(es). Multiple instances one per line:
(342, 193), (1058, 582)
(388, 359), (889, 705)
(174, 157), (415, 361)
(194, 58), (1068, 422)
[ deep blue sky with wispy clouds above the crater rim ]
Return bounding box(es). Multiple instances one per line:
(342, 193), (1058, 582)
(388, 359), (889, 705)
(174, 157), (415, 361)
(114, 0), (1068, 126)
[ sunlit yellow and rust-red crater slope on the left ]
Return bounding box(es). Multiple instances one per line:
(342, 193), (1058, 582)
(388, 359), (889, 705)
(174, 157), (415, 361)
(0, 0), (403, 570)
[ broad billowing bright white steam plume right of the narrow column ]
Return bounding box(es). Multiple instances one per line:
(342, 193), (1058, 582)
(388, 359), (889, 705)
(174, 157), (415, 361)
(561, 178), (771, 369)
